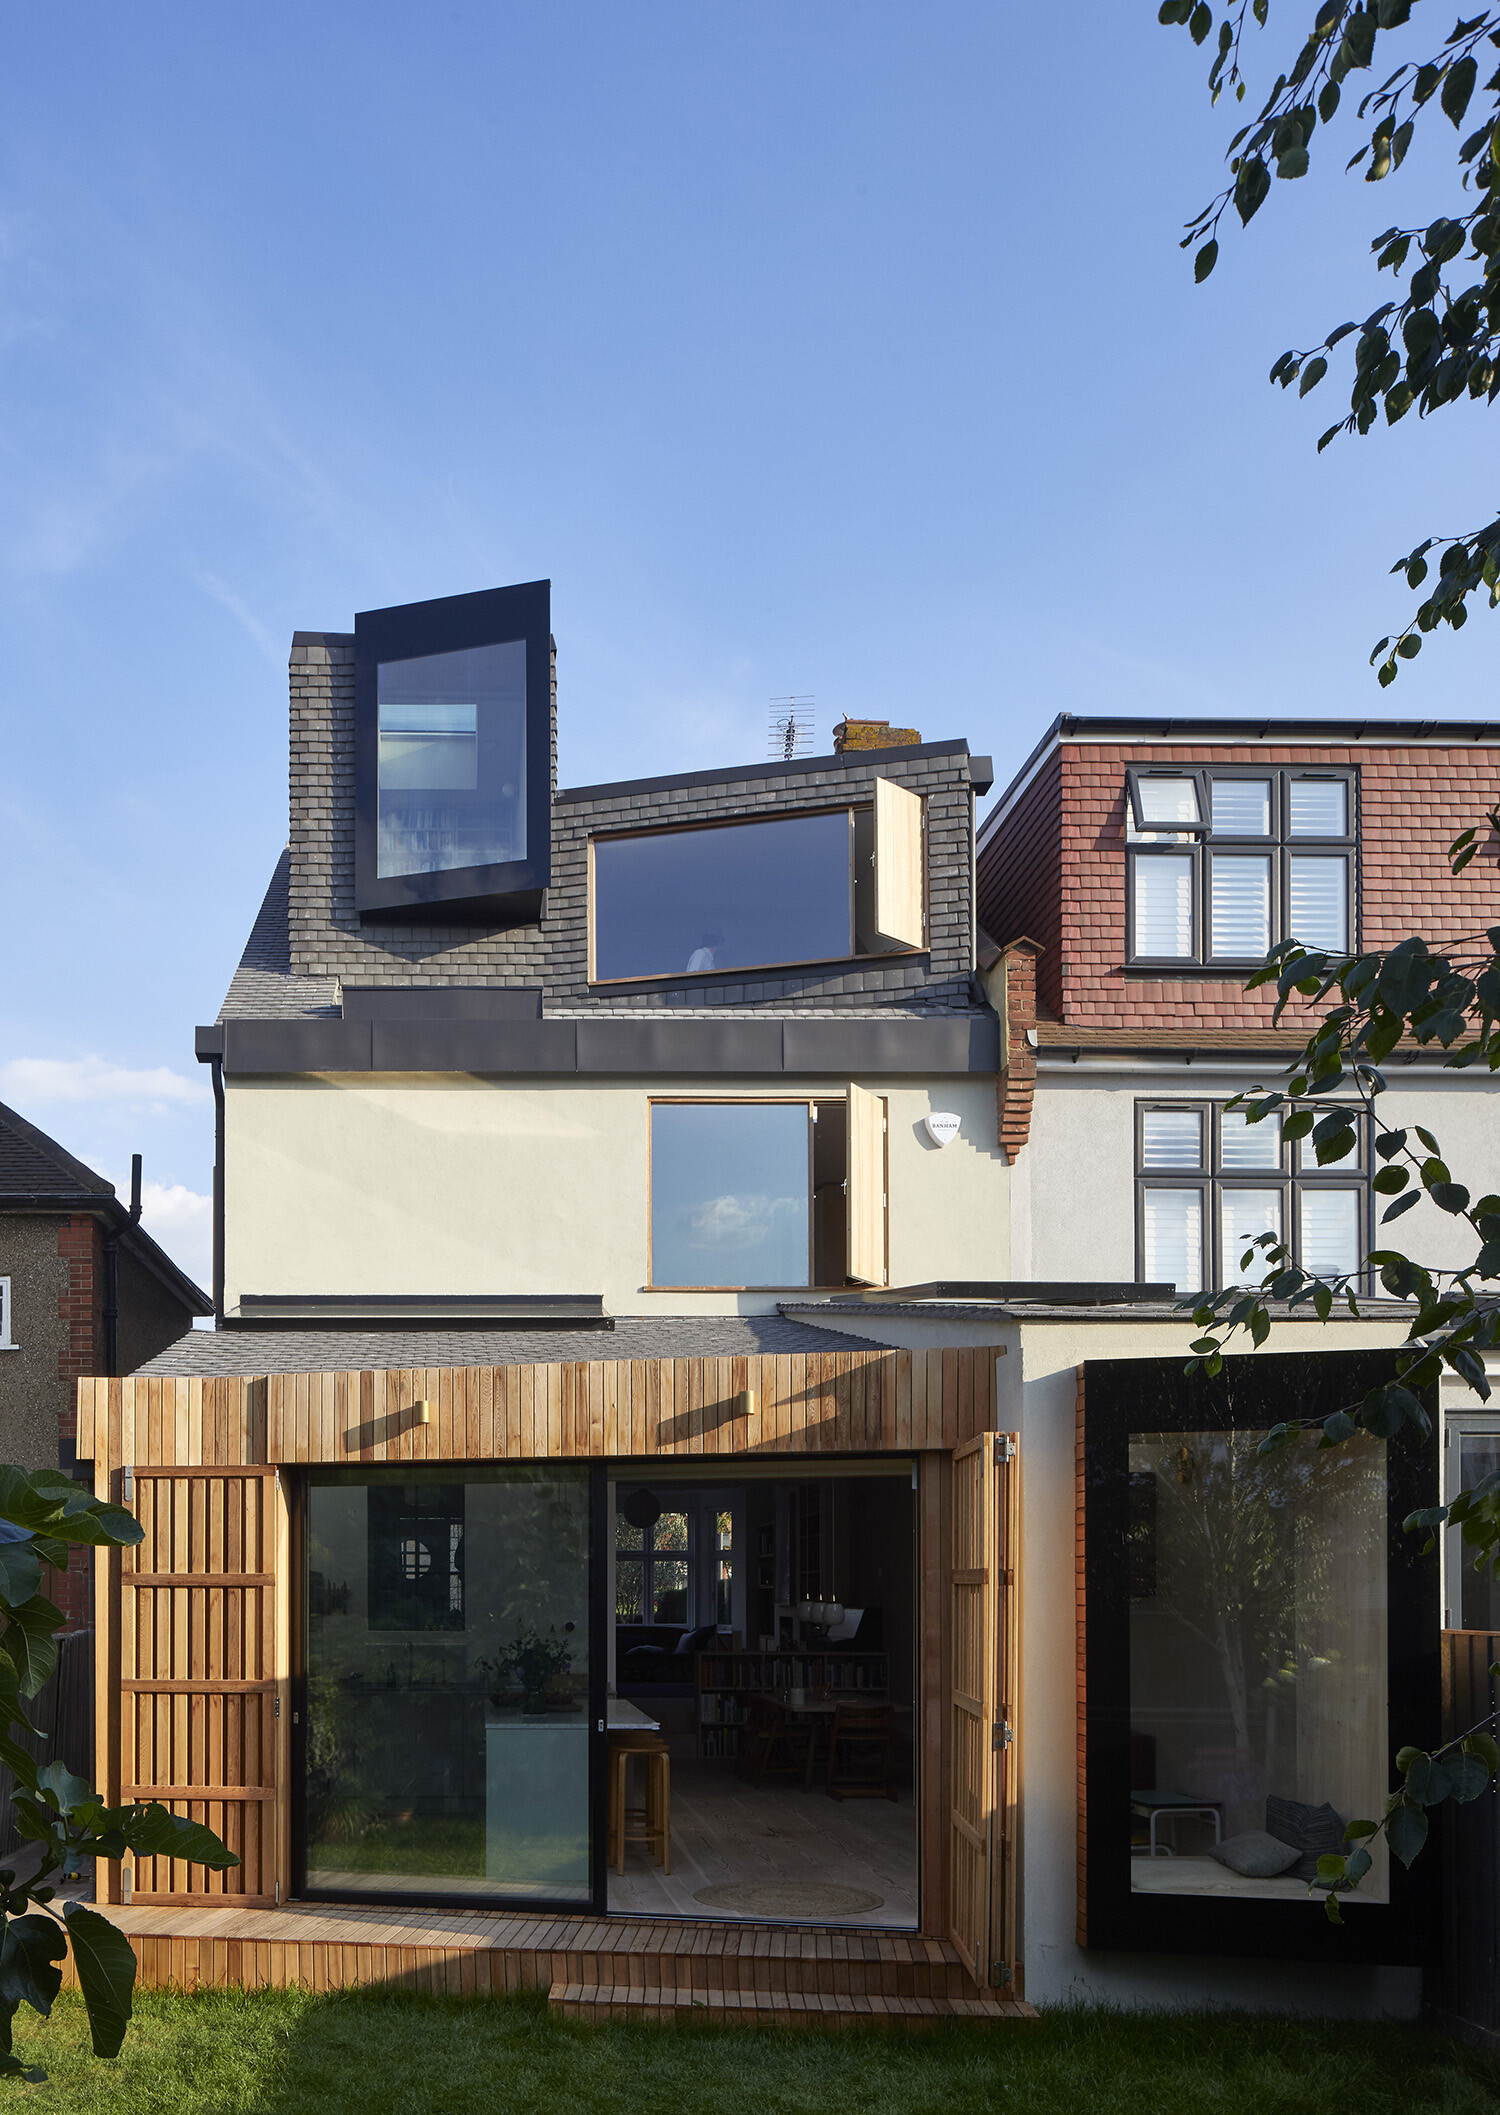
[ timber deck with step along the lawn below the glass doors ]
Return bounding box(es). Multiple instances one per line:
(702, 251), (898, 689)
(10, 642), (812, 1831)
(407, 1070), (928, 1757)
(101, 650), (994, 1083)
(81, 1904), (1035, 2026)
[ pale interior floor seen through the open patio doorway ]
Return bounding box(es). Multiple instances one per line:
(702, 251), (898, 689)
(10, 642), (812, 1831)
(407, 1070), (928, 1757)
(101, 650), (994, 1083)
(609, 1760), (918, 1931)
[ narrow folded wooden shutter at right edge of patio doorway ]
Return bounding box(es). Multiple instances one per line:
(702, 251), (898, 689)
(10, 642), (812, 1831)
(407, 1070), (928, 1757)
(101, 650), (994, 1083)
(948, 1432), (1020, 1994)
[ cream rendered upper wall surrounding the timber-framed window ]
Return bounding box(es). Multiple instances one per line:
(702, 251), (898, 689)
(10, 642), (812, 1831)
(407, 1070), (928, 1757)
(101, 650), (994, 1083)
(224, 1074), (1009, 1313)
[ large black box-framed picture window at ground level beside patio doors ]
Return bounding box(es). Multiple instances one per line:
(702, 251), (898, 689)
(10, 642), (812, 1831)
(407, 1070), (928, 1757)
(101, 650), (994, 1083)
(1081, 1351), (1441, 1961)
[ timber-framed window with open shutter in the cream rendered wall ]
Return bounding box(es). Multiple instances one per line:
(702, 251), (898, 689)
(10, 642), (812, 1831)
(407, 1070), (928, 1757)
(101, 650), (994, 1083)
(650, 1085), (886, 1292)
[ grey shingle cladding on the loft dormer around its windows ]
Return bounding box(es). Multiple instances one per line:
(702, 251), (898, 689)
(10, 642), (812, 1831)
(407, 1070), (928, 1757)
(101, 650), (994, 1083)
(290, 635), (973, 1013)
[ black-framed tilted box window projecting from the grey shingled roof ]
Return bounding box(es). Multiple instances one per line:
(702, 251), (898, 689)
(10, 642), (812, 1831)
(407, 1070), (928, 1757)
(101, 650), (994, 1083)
(353, 580), (552, 926)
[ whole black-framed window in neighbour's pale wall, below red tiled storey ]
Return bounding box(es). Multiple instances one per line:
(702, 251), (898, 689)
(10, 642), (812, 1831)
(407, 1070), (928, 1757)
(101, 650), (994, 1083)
(1136, 1102), (1371, 1294)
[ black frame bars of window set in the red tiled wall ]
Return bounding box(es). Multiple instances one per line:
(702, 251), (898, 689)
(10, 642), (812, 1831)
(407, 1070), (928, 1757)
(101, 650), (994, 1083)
(1126, 764), (1360, 975)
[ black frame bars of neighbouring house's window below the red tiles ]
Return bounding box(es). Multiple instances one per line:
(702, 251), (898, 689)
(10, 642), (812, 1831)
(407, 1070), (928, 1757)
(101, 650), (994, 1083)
(1134, 1096), (1375, 1294)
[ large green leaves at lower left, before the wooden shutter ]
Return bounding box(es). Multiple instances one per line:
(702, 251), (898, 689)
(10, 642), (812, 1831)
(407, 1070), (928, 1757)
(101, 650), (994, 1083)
(0, 1468), (239, 2081)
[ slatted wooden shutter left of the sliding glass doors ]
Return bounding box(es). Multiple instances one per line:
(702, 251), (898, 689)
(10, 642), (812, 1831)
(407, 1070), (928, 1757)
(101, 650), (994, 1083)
(118, 1468), (283, 1906)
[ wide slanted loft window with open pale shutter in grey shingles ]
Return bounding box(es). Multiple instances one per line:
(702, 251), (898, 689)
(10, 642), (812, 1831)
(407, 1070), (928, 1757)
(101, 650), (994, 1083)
(588, 778), (927, 983)
